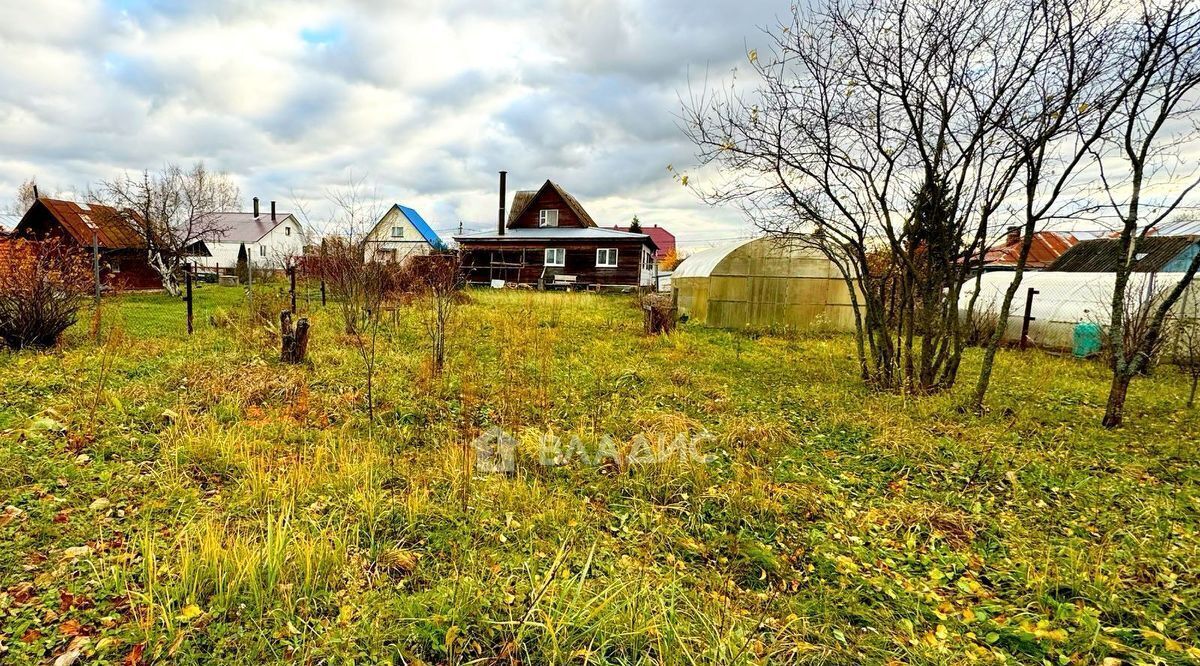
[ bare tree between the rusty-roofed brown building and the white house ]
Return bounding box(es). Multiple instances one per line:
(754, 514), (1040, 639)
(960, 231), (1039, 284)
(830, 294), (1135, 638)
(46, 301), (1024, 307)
(98, 162), (240, 295)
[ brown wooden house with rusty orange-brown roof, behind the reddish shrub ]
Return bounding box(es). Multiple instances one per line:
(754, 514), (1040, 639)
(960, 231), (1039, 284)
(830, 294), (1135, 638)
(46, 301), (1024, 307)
(12, 197), (162, 289)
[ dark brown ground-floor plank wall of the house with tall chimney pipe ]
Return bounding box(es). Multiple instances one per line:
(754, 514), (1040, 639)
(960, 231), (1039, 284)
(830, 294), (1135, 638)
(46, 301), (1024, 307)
(462, 241), (642, 287)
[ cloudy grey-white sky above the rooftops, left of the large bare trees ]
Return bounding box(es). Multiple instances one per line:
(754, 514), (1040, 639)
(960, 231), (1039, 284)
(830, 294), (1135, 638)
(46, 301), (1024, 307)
(0, 0), (788, 247)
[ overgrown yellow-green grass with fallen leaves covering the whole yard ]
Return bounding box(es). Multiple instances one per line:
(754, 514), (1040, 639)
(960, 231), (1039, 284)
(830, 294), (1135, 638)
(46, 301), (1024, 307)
(0, 287), (1200, 664)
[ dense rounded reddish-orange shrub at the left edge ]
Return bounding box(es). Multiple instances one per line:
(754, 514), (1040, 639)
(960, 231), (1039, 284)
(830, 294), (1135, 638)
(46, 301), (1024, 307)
(0, 238), (92, 349)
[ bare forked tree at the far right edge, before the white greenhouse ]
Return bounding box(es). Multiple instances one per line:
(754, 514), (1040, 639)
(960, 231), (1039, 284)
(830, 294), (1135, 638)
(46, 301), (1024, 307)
(1093, 0), (1200, 427)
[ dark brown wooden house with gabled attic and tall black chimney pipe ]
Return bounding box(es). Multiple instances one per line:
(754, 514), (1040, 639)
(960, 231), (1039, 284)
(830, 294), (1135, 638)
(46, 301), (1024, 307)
(455, 172), (656, 289)
